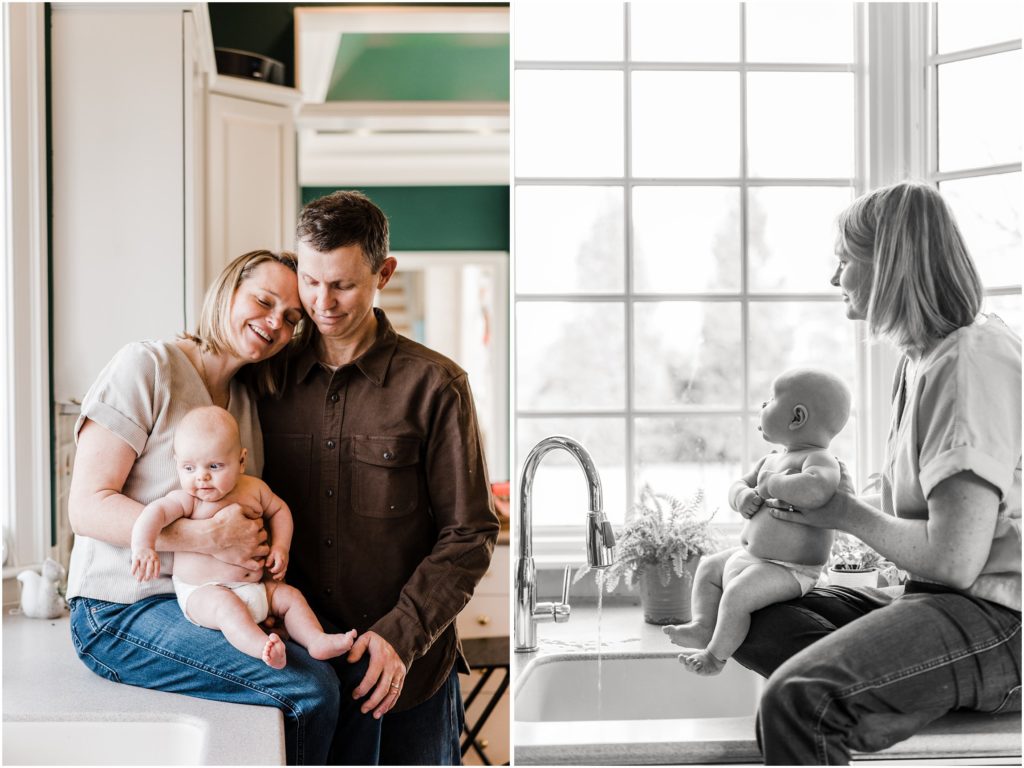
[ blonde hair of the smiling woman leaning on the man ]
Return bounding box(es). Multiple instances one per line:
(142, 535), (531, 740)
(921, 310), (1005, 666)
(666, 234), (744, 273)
(181, 250), (306, 394)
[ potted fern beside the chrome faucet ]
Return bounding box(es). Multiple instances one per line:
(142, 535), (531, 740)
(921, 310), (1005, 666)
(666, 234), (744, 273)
(577, 485), (719, 625)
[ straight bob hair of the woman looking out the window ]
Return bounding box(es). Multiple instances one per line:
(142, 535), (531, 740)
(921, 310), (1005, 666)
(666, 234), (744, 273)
(837, 181), (982, 352)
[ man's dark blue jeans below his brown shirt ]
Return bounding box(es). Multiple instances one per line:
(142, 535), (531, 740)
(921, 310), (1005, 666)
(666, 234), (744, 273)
(331, 658), (465, 765)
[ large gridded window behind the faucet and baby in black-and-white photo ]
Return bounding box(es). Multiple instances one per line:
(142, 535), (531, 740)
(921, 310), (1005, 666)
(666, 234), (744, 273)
(513, 2), (862, 559)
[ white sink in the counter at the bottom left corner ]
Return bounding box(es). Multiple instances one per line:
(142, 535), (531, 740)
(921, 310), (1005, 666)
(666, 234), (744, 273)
(3, 720), (206, 765)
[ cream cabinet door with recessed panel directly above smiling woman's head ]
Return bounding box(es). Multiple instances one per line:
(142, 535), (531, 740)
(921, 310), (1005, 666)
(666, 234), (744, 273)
(206, 93), (296, 285)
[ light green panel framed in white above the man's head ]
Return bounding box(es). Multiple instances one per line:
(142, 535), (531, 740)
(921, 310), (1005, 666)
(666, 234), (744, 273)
(327, 34), (509, 101)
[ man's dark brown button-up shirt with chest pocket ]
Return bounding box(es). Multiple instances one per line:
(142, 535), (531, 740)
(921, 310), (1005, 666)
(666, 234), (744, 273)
(259, 309), (498, 711)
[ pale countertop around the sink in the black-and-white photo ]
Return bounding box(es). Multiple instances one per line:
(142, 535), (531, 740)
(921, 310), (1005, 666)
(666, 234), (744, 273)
(512, 601), (1021, 765)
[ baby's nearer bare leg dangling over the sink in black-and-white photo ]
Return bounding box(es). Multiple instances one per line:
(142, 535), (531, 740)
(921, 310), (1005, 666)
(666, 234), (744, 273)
(679, 562), (802, 675)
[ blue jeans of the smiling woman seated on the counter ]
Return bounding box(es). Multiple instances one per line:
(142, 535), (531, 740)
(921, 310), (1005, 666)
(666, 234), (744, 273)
(71, 594), (373, 765)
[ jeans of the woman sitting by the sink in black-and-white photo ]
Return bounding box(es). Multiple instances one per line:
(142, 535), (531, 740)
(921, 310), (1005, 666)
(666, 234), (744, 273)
(735, 583), (1021, 765)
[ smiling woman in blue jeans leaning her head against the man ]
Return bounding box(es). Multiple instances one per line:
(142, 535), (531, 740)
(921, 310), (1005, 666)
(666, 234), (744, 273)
(68, 251), (374, 764)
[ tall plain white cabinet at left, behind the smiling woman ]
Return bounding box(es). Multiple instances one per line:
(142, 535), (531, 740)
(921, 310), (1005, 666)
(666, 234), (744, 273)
(50, 3), (215, 401)
